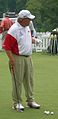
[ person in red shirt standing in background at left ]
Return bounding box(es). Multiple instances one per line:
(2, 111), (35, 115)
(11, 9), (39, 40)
(0, 14), (13, 40)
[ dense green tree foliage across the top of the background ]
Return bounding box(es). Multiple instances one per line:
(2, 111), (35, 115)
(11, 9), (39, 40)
(0, 0), (58, 31)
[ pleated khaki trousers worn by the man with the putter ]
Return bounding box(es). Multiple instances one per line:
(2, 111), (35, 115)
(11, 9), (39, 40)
(11, 55), (33, 103)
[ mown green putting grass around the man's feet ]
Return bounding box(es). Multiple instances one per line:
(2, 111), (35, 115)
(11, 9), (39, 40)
(0, 52), (58, 119)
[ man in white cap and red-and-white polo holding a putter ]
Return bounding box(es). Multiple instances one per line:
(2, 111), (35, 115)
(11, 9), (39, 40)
(3, 10), (40, 110)
